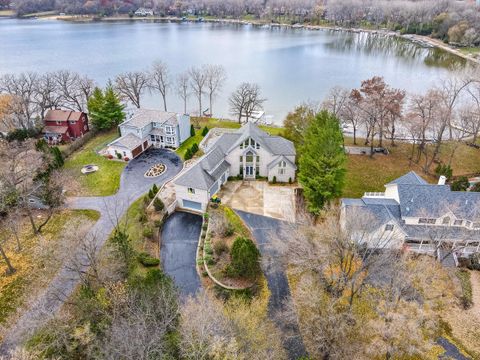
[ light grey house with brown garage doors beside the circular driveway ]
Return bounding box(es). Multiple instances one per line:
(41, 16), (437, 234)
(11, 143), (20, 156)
(108, 109), (190, 159)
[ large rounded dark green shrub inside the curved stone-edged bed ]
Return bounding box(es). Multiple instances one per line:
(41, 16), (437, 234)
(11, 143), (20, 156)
(230, 237), (260, 278)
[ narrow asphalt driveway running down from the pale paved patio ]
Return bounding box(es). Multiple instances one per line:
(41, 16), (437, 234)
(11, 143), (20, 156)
(235, 210), (306, 359)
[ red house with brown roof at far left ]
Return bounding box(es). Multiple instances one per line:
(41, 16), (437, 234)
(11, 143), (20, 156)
(42, 109), (89, 144)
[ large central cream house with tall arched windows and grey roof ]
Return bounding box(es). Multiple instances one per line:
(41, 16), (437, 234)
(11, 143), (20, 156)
(174, 123), (297, 211)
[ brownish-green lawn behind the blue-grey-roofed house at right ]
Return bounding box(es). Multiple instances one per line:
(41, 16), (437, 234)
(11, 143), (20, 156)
(342, 138), (480, 198)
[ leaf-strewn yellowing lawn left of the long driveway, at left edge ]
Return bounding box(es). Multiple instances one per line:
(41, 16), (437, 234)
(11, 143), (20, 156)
(0, 210), (100, 330)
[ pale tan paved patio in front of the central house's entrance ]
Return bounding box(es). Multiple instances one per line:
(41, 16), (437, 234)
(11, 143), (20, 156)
(218, 181), (296, 222)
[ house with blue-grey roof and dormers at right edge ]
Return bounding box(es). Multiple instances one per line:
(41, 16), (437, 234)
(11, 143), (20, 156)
(341, 171), (480, 260)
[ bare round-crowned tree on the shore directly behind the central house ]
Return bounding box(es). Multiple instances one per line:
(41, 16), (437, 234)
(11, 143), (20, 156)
(229, 83), (266, 123)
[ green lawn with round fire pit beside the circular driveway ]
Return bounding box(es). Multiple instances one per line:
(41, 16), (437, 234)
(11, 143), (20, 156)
(64, 130), (127, 196)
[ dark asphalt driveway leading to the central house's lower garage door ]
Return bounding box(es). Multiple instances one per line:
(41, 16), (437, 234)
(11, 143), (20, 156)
(160, 211), (202, 296)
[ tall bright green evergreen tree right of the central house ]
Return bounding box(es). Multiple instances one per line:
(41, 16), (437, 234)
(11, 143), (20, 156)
(298, 110), (346, 214)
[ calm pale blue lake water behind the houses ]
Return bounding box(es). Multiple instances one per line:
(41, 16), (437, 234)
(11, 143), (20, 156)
(0, 19), (462, 123)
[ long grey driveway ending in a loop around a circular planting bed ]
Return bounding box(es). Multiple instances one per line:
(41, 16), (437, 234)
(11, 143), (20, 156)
(0, 149), (184, 354)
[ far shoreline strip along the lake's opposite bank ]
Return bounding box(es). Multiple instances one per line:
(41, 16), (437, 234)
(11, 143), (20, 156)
(45, 15), (480, 64)
